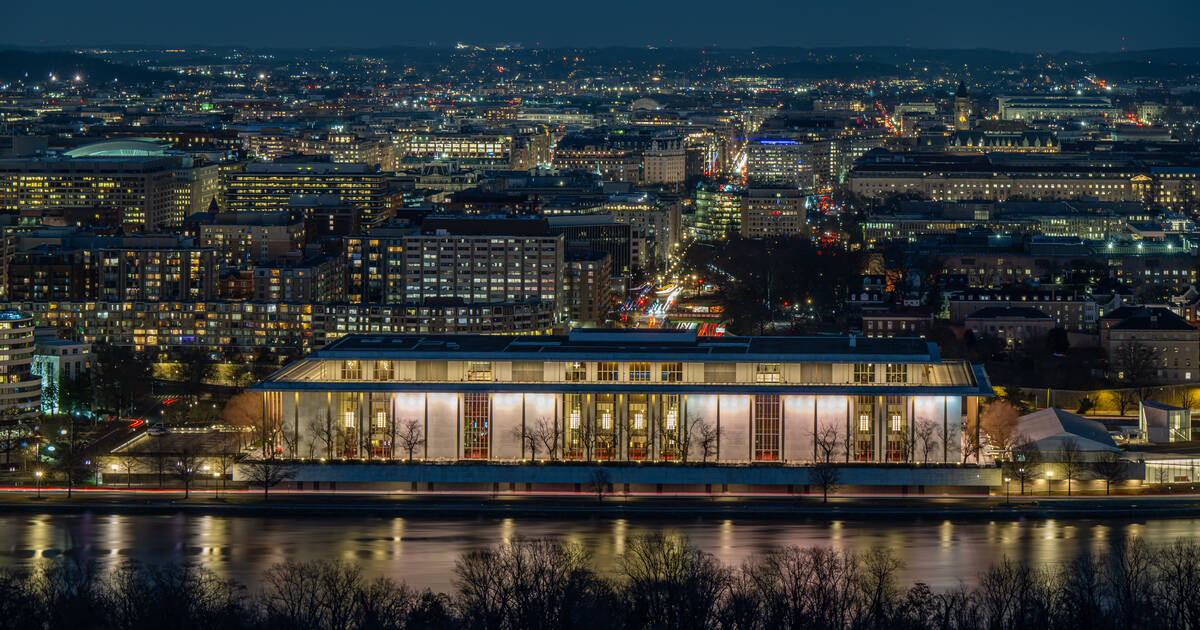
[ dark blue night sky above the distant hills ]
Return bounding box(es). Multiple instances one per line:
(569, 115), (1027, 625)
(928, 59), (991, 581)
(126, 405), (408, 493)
(0, 0), (1200, 52)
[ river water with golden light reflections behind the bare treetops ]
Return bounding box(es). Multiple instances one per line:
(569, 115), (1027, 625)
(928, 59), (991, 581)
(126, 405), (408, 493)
(0, 512), (1200, 592)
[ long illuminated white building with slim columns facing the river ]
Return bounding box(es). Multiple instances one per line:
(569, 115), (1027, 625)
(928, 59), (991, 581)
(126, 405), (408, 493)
(251, 329), (991, 463)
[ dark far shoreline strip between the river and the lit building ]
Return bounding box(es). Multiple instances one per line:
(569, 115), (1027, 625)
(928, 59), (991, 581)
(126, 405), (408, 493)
(0, 492), (1200, 521)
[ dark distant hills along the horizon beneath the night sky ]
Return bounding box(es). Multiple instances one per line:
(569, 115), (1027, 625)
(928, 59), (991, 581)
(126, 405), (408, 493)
(0, 46), (1200, 83)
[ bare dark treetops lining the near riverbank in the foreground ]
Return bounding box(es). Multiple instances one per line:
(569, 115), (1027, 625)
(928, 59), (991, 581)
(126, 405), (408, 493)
(0, 534), (1200, 630)
